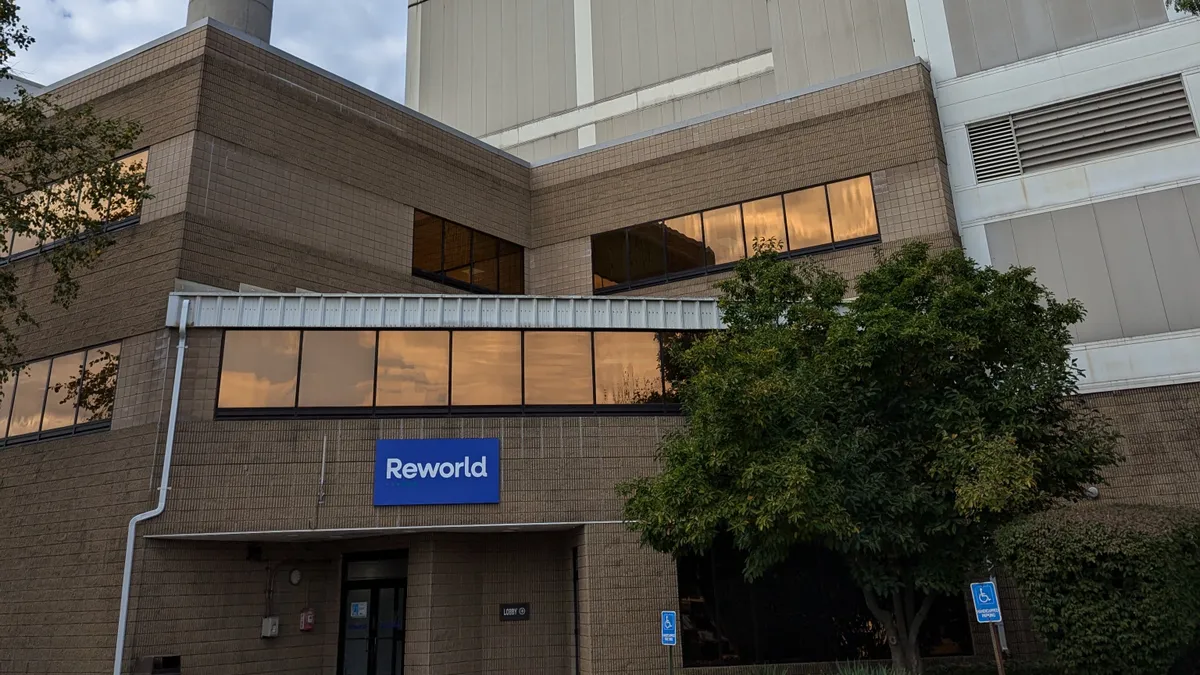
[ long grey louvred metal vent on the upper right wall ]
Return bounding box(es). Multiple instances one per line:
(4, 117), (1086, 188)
(967, 76), (1196, 183)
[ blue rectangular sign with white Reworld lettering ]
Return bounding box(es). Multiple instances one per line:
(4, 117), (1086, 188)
(374, 438), (500, 506)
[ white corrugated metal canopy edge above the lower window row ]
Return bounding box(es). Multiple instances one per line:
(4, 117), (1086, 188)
(167, 293), (725, 330)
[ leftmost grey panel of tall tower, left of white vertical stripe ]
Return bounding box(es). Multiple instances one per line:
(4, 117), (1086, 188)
(406, 0), (576, 136)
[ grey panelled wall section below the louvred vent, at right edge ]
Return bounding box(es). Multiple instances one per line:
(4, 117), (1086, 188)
(986, 185), (1200, 342)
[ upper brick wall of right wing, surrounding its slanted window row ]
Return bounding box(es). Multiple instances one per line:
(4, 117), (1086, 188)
(529, 65), (956, 297)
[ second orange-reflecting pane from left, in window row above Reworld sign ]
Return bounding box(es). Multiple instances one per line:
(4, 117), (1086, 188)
(300, 330), (374, 407)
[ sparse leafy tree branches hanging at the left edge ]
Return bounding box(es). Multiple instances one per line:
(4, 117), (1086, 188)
(0, 0), (150, 378)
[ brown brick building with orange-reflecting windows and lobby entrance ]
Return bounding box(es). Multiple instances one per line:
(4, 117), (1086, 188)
(0, 2), (1200, 675)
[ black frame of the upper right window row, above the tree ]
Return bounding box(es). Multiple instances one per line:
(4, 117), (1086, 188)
(588, 173), (882, 295)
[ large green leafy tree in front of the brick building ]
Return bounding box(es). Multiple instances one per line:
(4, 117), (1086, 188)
(619, 244), (1118, 673)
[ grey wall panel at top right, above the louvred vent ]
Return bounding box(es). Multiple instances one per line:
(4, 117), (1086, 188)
(944, 0), (1166, 76)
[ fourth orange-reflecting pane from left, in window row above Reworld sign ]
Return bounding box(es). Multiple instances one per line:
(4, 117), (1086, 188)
(450, 330), (521, 406)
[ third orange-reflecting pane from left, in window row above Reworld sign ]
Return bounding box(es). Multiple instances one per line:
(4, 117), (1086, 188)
(376, 330), (450, 406)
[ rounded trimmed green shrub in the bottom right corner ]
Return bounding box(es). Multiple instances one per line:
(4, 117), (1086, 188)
(997, 504), (1200, 675)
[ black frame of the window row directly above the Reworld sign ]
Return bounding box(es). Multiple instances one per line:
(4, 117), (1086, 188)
(212, 327), (709, 420)
